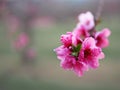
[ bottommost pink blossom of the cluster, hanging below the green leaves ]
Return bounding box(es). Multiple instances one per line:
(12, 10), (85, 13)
(60, 55), (88, 76)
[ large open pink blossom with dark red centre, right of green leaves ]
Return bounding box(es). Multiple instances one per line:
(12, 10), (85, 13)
(79, 37), (104, 68)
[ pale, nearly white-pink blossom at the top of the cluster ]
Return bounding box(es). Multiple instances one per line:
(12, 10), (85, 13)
(78, 12), (95, 31)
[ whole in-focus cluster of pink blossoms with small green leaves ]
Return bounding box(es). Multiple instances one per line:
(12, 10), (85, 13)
(54, 12), (111, 76)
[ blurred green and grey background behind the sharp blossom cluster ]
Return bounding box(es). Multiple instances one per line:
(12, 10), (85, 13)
(0, 0), (120, 90)
